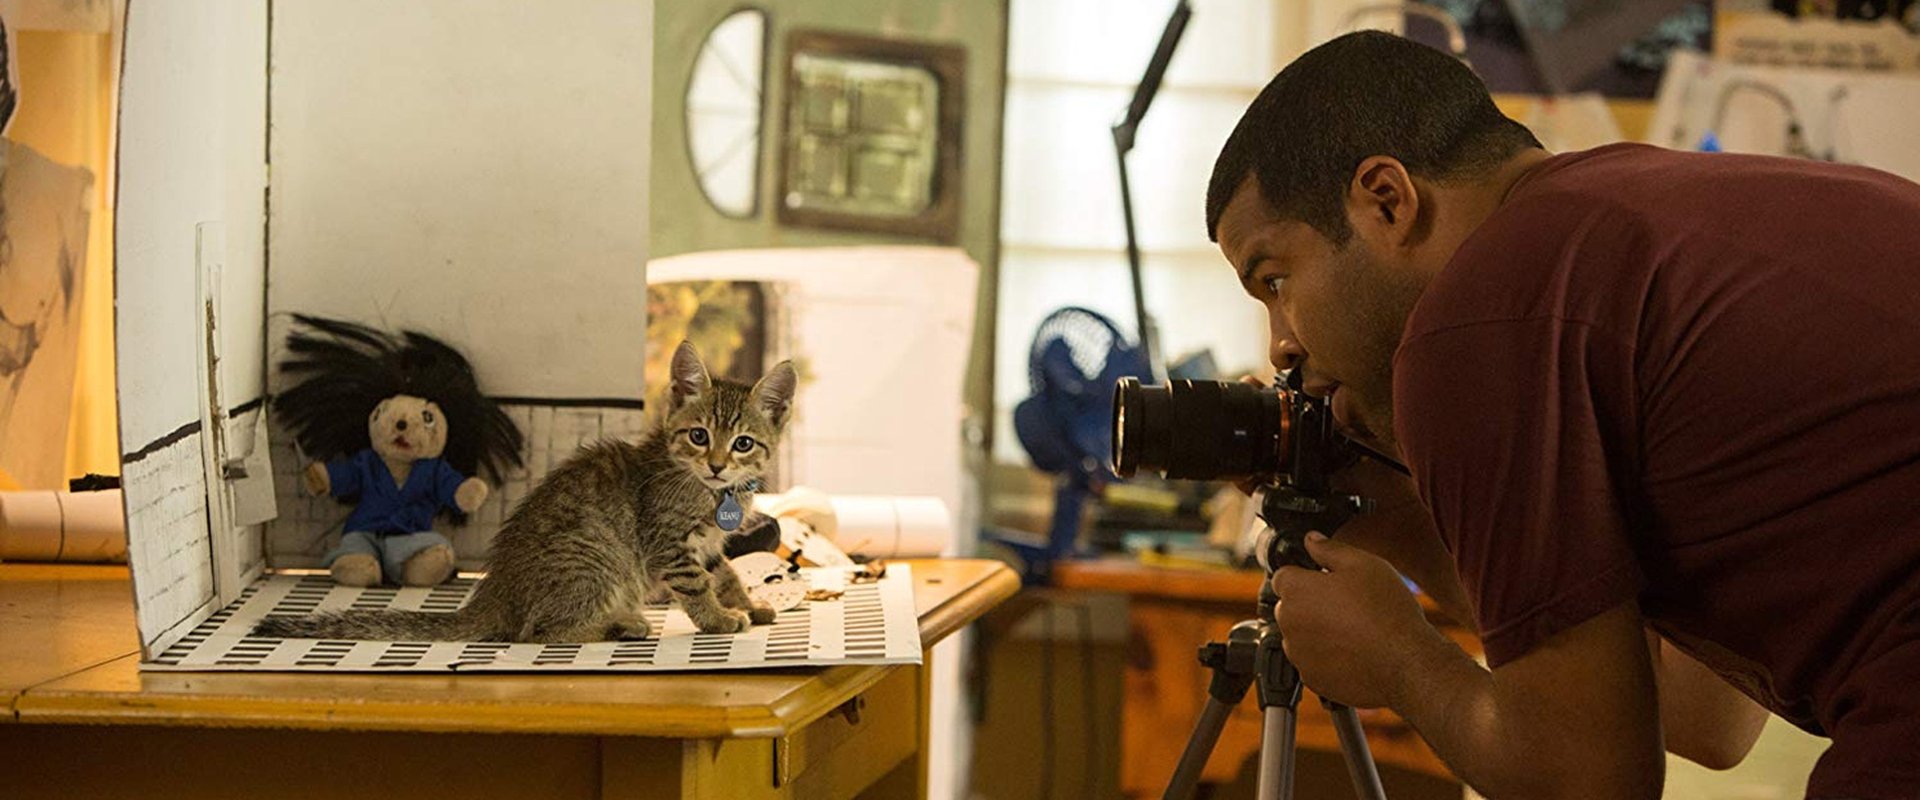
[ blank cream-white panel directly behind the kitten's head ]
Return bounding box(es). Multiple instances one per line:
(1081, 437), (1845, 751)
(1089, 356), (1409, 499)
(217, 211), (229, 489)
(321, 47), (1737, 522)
(647, 247), (979, 553)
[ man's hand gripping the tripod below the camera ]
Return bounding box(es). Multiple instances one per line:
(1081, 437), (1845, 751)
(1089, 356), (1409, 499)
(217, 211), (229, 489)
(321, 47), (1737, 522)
(1273, 533), (1452, 708)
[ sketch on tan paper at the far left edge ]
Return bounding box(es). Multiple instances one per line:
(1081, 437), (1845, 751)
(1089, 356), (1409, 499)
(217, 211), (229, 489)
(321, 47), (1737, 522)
(0, 7), (94, 489)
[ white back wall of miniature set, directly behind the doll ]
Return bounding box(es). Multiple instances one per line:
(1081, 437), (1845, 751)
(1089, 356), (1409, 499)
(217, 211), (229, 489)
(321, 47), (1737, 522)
(267, 0), (653, 568)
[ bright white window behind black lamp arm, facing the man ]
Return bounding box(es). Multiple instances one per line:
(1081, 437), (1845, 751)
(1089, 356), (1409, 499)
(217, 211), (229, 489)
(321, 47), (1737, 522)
(993, 0), (1286, 464)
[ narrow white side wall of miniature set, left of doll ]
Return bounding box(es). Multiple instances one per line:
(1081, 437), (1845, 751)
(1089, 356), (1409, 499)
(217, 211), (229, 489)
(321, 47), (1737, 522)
(115, 0), (267, 648)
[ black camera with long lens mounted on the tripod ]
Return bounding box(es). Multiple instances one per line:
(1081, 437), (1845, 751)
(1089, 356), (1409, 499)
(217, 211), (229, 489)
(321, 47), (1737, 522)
(1114, 370), (1374, 572)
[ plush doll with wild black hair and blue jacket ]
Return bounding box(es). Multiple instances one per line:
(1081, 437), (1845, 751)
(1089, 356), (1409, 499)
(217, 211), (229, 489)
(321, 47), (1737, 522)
(273, 315), (520, 587)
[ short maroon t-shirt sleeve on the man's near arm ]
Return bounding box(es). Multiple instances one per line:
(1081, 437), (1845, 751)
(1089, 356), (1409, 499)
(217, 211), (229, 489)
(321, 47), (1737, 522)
(1394, 318), (1642, 666)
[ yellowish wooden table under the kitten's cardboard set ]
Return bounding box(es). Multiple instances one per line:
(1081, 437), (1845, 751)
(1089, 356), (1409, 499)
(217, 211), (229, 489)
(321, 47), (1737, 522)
(0, 560), (1020, 800)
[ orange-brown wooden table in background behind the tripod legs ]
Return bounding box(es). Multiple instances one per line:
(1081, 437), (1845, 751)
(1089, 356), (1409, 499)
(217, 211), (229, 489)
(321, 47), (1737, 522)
(1054, 558), (1478, 796)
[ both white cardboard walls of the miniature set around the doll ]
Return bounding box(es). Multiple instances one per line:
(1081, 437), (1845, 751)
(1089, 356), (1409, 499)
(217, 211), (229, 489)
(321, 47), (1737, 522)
(115, 0), (653, 652)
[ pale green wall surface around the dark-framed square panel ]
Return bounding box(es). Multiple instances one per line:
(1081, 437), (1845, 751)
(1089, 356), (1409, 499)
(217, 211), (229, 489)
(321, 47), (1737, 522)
(651, 0), (1008, 529)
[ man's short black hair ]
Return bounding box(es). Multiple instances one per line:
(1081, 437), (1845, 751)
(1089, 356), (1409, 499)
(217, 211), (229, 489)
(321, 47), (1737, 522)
(1206, 31), (1540, 246)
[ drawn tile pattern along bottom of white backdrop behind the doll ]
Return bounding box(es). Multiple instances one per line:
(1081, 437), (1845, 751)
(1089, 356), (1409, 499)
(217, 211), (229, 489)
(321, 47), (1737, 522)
(265, 403), (647, 570)
